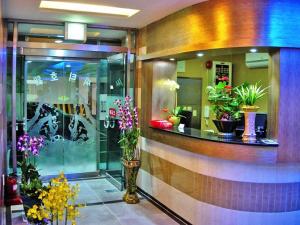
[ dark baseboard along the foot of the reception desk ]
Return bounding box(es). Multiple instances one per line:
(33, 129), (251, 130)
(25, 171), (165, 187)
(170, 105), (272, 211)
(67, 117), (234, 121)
(138, 187), (191, 225)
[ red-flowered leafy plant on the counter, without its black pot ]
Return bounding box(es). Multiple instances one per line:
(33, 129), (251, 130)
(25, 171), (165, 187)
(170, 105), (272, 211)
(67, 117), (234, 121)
(207, 81), (240, 121)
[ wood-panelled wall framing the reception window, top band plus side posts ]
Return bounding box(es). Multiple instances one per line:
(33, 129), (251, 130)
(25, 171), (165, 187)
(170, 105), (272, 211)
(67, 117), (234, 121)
(138, 0), (300, 162)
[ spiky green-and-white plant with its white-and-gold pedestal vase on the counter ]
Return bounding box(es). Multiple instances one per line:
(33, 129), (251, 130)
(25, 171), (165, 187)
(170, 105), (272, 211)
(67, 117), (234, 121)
(235, 82), (269, 142)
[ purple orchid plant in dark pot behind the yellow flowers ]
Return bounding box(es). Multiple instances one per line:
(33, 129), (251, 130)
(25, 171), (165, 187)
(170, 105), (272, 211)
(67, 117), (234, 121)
(17, 134), (44, 213)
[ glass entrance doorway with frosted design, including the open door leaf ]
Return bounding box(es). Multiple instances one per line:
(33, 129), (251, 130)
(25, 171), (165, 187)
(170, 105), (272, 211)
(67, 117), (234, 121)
(17, 53), (127, 185)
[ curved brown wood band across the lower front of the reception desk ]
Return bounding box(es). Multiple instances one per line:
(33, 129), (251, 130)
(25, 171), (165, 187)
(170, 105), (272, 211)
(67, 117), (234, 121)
(141, 151), (300, 212)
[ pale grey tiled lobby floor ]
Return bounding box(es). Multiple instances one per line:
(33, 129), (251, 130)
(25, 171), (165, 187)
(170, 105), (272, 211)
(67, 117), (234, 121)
(12, 179), (177, 225)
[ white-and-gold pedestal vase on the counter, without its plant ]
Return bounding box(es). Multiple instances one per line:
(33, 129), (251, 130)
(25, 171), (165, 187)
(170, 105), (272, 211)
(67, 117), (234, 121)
(242, 105), (259, 142)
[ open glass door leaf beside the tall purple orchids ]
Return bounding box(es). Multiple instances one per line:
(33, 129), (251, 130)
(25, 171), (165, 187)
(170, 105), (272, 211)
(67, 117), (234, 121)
(98, 53), (126, 189)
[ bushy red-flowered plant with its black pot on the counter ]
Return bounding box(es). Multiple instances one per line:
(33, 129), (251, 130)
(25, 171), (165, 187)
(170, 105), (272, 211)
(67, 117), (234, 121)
(207, 81), (240, 137)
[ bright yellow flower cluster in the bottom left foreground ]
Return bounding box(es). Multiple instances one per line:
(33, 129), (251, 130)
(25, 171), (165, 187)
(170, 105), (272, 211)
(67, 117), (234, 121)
(27, 173), (81, 225)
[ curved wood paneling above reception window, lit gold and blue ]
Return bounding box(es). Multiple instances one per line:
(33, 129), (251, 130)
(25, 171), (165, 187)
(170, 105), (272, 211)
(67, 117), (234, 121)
(139, 0), (300, 59)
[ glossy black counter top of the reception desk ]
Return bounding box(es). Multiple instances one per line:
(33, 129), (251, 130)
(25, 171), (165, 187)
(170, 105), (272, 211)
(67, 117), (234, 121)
(151, 127), (278, 147)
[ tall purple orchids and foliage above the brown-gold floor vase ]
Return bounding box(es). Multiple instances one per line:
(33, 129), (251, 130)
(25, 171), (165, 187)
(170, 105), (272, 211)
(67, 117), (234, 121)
(114, 96), (140, 161)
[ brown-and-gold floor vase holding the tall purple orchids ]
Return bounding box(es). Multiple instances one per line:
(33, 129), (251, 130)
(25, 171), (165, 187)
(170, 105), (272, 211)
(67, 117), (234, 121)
(123, 159), (141, 204)
